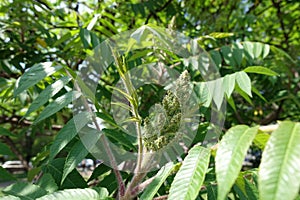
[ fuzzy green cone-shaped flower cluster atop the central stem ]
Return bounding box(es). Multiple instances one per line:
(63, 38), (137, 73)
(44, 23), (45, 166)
(143, 71), (190, 151)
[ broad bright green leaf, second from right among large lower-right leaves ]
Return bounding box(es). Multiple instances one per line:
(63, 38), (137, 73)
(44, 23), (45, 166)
(216, 125), (258, 200)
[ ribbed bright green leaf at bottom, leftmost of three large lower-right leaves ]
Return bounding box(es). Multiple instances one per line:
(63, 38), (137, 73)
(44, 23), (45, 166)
(168, 146), (210, 200)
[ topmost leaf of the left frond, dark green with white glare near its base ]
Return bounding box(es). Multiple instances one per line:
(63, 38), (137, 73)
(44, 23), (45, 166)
(14, 62), (62, 97)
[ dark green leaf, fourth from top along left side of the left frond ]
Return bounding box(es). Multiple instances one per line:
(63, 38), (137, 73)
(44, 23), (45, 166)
(49, 112), (90, 160)
